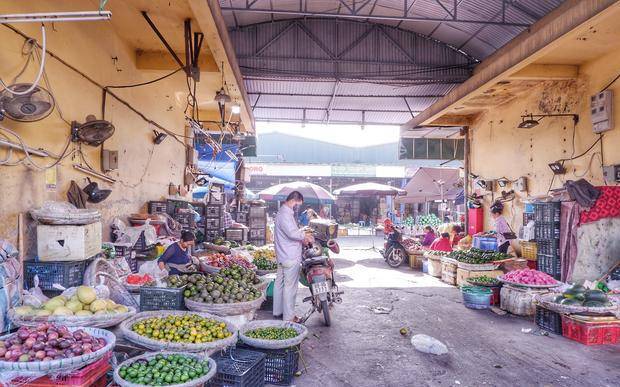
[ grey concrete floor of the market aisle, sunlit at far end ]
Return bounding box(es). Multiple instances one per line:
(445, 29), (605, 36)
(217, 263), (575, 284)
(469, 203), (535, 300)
(259, 237), (620, 387)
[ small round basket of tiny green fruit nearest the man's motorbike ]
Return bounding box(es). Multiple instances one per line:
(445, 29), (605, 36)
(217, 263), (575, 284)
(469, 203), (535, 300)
(239, 320), (308, 349)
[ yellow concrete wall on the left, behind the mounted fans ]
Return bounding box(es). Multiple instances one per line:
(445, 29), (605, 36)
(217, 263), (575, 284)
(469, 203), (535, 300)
(0, 6), (194, 252)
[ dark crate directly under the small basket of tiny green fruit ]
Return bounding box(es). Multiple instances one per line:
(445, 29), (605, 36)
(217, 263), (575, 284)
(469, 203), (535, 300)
(239, 344), (301, 386)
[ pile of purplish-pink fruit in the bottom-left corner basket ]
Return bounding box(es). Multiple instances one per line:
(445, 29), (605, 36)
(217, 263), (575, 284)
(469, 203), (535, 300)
(0, 323), (106, 362)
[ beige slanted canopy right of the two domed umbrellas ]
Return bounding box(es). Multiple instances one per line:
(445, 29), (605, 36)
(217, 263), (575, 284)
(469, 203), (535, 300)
(396, 167), (462, 203)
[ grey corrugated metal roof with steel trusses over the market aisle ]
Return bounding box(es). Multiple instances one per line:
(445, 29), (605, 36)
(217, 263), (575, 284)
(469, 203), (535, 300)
(220, 0), (562, 124)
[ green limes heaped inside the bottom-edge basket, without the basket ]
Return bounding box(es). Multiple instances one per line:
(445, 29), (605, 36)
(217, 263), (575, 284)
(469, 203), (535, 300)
(118, 354), (209, 386)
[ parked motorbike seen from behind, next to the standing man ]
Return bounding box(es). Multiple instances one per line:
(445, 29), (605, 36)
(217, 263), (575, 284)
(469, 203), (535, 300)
(299, 220), (344, 326)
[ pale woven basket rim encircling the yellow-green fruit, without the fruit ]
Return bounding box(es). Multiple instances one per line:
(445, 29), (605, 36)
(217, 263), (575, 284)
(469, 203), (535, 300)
(120, 310), (237, 352)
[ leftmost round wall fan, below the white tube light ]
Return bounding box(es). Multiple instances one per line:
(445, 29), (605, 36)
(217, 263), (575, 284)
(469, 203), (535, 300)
(0, 83), (55, 122)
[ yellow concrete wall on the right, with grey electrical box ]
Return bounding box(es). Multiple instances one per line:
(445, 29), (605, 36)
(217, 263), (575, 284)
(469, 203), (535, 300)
(471, 50), (620, 230)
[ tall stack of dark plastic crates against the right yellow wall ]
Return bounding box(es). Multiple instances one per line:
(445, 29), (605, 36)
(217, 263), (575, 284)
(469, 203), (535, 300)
(534, 202), (562, 280)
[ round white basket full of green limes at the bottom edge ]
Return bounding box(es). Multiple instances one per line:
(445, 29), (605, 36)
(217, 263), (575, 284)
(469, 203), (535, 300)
(114, 352), (217, 387)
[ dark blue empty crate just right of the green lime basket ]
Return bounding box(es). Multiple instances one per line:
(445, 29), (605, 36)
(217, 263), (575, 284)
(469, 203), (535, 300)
(207, 348), (266, 387)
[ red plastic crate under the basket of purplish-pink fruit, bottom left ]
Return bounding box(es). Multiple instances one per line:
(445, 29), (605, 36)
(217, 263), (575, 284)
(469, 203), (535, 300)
(6, 352), (112, 387)
